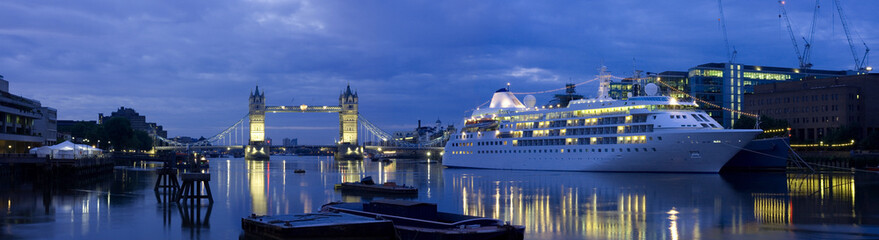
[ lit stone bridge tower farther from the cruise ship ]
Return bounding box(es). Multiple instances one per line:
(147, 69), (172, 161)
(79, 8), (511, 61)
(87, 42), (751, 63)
(244, 86), (269, 160)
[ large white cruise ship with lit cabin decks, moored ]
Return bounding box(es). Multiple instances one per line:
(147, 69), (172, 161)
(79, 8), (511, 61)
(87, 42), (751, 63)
(443, 76), (762, 173)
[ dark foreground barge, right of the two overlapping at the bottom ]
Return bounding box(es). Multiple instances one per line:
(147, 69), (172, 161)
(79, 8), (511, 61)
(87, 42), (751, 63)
(321, 199), (525, 239)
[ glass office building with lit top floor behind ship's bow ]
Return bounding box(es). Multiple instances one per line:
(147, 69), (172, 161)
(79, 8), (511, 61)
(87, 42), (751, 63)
(687, 63), (856, 127)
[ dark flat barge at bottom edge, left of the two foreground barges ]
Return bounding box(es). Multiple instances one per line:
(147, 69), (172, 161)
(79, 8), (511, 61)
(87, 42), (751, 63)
(241, 212), (397, 240)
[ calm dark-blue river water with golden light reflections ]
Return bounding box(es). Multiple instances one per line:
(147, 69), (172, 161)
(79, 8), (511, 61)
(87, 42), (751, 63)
(0, 157), (879, 239)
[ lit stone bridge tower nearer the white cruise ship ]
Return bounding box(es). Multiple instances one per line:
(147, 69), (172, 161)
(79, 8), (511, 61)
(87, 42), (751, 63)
(335, 85), (363, 159)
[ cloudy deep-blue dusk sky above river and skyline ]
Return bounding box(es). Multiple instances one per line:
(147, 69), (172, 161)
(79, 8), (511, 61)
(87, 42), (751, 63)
(0, 0), (879, 144)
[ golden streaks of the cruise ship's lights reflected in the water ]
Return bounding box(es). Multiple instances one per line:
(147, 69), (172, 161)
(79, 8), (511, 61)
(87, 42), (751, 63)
(453, 176), (655, 239)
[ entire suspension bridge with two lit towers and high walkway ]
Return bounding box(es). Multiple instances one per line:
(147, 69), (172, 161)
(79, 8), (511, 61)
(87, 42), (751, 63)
(154, 85), (448, 160)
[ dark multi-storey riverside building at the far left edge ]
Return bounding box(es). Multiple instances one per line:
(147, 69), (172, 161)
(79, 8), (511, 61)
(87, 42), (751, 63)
(0, 76), (58, 153)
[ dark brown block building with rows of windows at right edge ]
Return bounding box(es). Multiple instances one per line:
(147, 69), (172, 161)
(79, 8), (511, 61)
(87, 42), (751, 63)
(744, 74), (879, 142)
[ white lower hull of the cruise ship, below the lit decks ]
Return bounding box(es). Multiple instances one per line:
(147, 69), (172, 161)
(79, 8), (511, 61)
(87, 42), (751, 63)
(443, 129), (762, 173)
